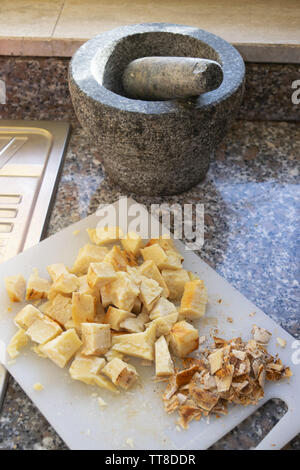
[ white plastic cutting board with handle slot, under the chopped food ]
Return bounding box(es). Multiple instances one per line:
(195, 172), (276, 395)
(0, 200), (300, 450)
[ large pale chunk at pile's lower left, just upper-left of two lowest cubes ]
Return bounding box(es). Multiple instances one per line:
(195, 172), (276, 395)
(40, 329), (82, 368)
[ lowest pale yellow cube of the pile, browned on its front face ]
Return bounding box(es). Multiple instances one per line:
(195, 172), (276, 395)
(103, 357), (138, 390)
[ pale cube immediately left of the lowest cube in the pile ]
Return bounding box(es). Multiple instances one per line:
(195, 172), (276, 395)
(69, 354), (106, 385)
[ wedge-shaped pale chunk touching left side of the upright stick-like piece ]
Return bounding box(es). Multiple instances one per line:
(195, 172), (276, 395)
(112, 324), (156, 361)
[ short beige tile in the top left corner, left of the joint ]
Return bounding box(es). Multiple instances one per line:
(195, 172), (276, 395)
(0, 0), (63, 38)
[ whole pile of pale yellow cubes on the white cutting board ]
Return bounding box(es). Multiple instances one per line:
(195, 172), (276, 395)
(5, 227), (207, 392)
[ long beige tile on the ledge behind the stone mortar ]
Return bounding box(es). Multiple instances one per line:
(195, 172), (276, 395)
(54, 0), (300, 44)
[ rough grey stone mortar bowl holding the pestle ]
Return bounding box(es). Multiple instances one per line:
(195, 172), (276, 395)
(69, 23), (245, 195)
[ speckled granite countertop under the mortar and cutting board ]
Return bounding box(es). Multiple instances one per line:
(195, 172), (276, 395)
(0, 121), (300, 449)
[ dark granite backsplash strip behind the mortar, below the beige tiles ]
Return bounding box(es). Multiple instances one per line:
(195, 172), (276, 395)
(0, 56), (300, 125)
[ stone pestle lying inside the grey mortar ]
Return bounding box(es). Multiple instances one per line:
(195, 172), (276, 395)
(123, 57), (223, 100)
